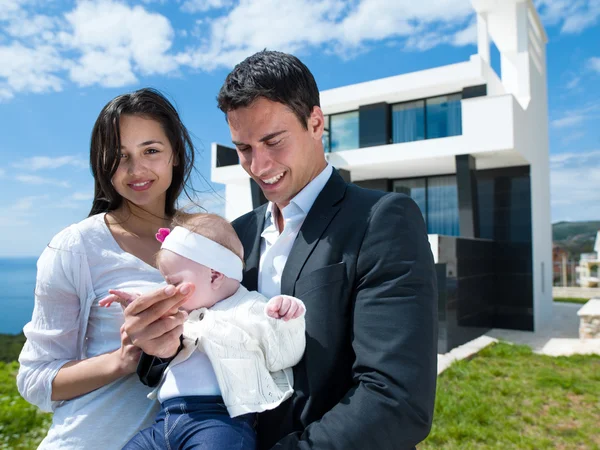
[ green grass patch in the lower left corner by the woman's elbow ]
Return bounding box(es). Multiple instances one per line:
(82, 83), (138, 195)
(0, 362), (51, 450)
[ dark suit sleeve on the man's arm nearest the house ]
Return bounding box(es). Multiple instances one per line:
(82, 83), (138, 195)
(274, 194), (437, 450)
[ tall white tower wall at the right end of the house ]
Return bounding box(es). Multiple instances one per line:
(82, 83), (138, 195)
(474, 0), (553, 329)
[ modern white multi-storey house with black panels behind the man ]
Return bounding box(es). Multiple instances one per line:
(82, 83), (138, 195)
(211, 0), (552, 350)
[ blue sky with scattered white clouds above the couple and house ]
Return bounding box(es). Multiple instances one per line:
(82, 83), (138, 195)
(0, 0), (600, 257)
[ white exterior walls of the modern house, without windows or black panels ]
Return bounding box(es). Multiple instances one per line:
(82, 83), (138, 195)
(211, 0), (552, 329)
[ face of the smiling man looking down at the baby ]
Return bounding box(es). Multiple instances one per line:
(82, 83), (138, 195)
(227, 97), (327, 209)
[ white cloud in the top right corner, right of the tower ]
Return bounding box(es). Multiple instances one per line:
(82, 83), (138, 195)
(535, 0), (600, 34)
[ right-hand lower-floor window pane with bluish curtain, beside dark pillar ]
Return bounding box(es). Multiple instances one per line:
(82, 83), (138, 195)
(427, 175), (460, 236)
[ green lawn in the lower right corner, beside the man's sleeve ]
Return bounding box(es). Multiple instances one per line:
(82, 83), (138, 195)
(419, 343), (600, 450)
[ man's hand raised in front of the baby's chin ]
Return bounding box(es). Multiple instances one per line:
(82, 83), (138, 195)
(123, 283), (194, 358)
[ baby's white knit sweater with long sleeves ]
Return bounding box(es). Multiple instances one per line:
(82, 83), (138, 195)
(148, 286), (306, 417)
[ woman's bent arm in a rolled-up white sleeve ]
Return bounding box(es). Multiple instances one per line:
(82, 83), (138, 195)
(17, 227), (139, 411)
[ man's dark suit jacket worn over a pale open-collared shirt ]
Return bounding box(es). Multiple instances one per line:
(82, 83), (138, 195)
(233, 171), (437, 450)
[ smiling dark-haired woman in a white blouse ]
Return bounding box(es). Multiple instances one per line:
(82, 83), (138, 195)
(17, 89), (194, 449)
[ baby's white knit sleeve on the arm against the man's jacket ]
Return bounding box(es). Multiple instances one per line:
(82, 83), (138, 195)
(246, 298), (306, 372)
